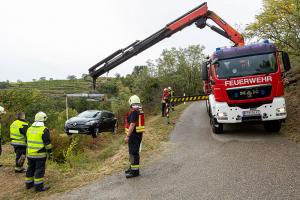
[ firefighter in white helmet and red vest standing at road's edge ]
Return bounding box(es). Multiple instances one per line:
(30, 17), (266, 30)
(125, 95), (145, 178)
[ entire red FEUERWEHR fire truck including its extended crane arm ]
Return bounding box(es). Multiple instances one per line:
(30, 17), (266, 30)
(89, 3), (290, 133)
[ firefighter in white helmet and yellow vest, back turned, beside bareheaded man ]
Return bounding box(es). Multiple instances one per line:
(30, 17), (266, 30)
(25, 112), (52, 192)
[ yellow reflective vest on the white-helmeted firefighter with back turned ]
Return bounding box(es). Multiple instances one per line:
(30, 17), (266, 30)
(26, 126), (51, 158)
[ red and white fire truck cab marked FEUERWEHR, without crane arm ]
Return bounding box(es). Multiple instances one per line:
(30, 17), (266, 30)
(202, 41), (290, 133)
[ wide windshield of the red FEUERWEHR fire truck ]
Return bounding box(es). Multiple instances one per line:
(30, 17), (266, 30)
(216, 53), (277, 79)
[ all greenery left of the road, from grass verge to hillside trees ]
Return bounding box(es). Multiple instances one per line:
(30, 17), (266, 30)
(0, 45), (204, 199)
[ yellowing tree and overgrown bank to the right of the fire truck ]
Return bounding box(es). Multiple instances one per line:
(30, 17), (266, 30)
(245, 0), (300, 142)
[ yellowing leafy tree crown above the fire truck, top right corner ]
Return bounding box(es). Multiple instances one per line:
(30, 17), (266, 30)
(245, 0), (300, 57)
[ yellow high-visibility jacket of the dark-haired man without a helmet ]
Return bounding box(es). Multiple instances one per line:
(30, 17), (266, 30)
(10, 119), (28, 146)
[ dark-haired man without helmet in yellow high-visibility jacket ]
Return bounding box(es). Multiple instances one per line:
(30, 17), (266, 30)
(10, 112), (28, 173)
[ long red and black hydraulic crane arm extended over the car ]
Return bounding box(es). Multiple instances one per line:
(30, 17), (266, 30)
(89, 2), (244, 87)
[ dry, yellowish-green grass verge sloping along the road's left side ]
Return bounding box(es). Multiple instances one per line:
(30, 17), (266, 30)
(0, 104), (186, 199)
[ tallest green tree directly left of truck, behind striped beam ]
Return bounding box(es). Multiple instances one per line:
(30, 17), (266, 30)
(156, 45), (205, 94)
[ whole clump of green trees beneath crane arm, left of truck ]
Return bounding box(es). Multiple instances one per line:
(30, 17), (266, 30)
(121, 45), (205, 103)
